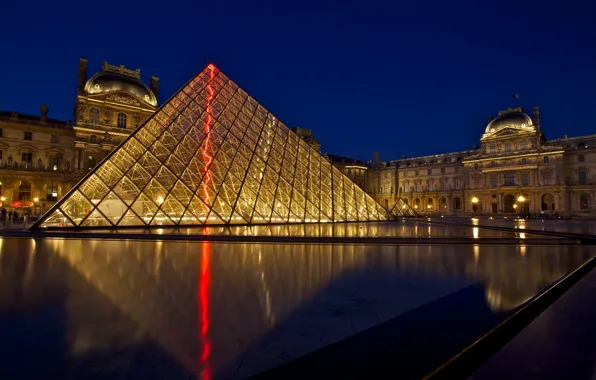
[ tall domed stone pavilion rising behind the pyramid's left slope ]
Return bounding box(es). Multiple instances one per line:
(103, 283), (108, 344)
(74, 58), (159, 172)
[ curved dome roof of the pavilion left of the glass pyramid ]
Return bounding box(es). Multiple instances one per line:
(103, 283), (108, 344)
(85, 72), (157, 106)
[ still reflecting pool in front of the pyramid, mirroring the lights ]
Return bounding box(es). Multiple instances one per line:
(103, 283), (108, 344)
(0, 238), (594, 379)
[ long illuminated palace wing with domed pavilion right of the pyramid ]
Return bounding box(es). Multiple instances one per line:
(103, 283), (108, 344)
(365, 108), (596, 217)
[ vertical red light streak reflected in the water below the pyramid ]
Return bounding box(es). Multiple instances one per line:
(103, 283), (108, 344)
(197, 242), (211, 380)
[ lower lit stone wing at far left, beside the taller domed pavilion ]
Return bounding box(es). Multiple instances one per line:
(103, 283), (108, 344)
(0, 106), (80, 215)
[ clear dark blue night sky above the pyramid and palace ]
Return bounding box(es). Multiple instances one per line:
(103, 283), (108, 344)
(0, 0), (596, 159)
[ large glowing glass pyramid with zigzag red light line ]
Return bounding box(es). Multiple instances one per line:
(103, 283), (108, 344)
(34, 65), (386, 228)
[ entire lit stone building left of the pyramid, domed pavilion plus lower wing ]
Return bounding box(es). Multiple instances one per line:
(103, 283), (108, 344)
(0, 59), (159, 215)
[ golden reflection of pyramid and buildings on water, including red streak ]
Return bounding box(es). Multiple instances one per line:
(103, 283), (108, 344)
(0, 239), (592, 379)
